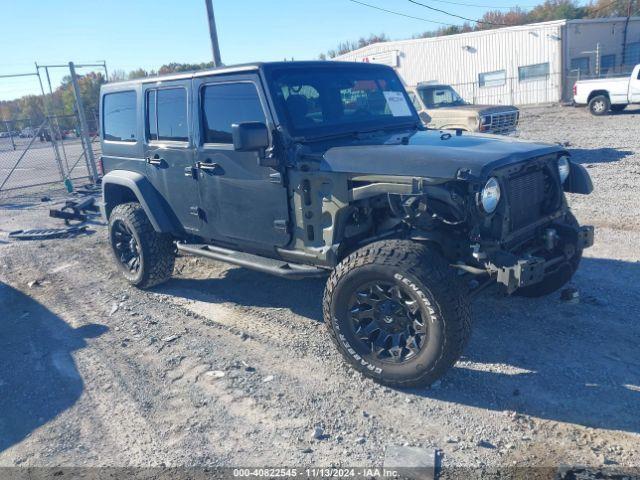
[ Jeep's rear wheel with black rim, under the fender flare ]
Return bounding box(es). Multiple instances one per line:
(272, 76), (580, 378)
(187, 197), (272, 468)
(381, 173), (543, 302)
(109, 203), (175, 288)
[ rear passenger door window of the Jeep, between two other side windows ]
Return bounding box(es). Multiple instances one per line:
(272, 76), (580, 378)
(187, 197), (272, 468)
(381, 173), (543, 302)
(146, 87), (189, 142)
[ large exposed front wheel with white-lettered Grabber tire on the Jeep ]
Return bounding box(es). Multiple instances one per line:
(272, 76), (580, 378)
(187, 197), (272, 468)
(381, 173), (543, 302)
(323, 240), (471, 387)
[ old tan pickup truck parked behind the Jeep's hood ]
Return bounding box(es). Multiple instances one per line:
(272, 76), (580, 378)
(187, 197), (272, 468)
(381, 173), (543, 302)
(408, 83), (520, 134)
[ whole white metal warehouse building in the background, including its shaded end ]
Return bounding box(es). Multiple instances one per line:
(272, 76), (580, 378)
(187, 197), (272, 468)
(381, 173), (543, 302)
(336, 17), (640, 105)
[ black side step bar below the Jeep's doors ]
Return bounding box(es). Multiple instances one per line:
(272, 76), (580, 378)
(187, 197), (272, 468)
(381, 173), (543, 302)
(176, 242), (329, 280)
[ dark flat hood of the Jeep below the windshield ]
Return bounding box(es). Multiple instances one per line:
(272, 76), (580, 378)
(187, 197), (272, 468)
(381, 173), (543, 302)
(320, 130), (566, 179)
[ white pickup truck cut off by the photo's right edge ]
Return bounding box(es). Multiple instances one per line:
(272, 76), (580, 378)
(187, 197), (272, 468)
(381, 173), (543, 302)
(573, 64), (640, 115)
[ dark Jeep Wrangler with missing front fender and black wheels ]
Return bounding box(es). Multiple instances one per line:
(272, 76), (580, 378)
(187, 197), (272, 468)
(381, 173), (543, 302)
(100, 62), (593, 387)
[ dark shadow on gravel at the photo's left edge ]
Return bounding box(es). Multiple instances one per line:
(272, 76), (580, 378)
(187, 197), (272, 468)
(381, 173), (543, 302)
(0, 282), (107, 452)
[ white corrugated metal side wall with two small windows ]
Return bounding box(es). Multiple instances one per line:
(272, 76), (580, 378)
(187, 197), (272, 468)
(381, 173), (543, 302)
(337, 21), (565, 105)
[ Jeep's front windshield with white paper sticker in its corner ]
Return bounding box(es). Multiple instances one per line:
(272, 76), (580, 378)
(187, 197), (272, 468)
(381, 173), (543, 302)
(268, 62), (418, 137)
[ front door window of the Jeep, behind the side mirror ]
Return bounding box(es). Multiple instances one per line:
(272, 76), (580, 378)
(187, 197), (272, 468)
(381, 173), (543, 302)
(202, 82), (266, 143)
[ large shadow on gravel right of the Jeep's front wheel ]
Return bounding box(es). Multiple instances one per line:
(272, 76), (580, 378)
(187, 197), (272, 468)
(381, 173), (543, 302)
(413, 258), (640, 432)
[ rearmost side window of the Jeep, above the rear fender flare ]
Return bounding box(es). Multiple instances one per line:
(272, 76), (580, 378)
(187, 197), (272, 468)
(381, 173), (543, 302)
(102, 91), (138, 142)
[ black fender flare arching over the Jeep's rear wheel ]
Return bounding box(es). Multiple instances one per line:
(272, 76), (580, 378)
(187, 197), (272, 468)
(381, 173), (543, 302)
(102, 170), (175, 233)
